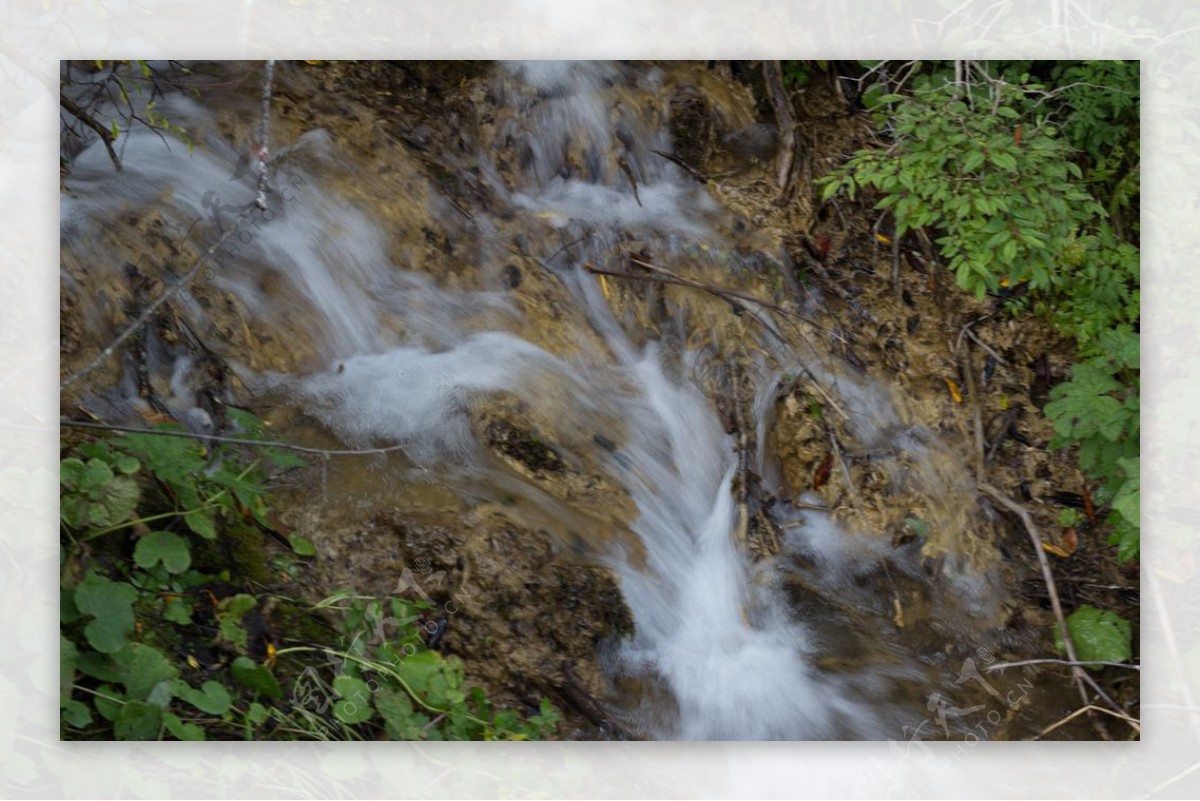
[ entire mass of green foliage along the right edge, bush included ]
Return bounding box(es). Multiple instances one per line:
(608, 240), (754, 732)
(818, 61), (1140, 561)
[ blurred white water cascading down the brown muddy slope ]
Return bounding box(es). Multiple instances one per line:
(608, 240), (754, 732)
(62, 62), (1027, 740)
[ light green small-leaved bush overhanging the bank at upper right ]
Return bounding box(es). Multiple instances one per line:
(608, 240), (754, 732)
(820, 75), (1103, 296)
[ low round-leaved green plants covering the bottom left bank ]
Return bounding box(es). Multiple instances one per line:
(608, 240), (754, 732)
(60, 422), (558, 740)
